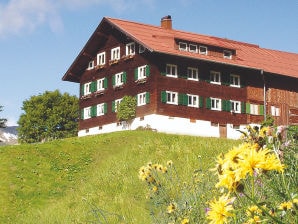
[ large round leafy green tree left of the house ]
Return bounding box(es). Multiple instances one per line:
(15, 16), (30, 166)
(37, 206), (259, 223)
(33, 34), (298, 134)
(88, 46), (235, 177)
(18, 90), (79, 143)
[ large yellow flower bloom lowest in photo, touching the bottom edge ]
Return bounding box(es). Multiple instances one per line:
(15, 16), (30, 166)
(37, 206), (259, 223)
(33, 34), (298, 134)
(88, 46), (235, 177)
(207, 195), (234, 224)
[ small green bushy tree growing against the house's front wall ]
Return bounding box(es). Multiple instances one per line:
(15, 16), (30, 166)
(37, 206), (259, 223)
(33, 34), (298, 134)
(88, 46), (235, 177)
(117, 96), (137, 127)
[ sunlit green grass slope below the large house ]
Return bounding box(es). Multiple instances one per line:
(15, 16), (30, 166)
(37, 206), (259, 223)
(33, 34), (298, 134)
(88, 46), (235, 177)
(0, 131), (239, 224)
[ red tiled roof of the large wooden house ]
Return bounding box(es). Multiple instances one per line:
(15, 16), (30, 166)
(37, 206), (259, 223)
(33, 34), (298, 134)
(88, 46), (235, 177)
(62, 17), (298, 82)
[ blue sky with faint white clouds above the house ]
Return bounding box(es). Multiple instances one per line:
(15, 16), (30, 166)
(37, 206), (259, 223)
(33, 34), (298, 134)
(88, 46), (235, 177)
(0, 0), (298, 125)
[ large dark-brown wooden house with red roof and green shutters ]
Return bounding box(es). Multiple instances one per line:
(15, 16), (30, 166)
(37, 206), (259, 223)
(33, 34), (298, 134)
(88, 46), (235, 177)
(62, 16), (298, 138)
